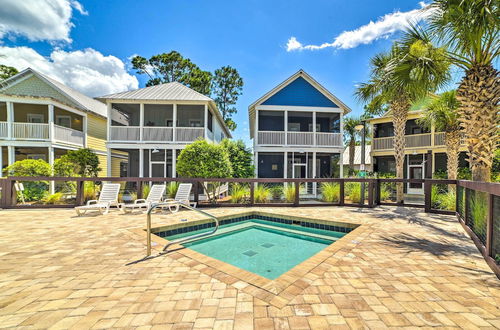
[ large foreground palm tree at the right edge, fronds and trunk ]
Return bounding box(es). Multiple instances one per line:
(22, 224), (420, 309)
(428, 0), (500, 181)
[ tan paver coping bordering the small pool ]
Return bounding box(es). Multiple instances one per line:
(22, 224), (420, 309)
(130, 211), (371, 308)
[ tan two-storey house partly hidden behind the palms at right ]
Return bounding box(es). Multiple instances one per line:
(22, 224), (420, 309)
(368, 104), (468, 194)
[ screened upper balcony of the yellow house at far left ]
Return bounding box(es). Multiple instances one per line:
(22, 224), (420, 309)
(0, 102), (85, 147)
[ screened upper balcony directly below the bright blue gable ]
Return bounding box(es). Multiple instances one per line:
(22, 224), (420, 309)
(256, 110), (343, 147)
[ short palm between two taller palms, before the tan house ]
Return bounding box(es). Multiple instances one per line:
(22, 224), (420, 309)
(418, 90), (461, 180)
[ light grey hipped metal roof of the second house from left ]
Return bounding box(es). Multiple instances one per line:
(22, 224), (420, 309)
(97, 82), (212, 102)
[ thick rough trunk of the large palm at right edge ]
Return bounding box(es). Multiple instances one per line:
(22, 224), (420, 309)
(457, 65), (500, 182)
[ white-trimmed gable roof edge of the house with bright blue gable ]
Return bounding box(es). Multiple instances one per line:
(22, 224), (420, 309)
(248, 69), (351, 138)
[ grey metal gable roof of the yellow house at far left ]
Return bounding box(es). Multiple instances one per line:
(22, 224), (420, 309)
(0, 68), (107, 117)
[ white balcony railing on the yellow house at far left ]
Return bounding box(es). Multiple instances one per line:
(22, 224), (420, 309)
(0, 122), (85, 146)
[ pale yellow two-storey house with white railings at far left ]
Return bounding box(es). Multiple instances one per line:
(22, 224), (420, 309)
(0, 68), (111, 176)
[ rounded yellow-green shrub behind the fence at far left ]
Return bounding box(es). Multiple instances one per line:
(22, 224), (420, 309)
(6, 159), (52, 202)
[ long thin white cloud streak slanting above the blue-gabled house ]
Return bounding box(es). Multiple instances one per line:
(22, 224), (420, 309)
(286, 2), (429, 52)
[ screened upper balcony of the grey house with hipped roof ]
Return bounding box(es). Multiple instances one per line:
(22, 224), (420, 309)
(109, 103), (213, 143)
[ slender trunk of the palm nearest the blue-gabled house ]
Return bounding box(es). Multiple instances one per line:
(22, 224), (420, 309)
(391, 97), (410, 203)
